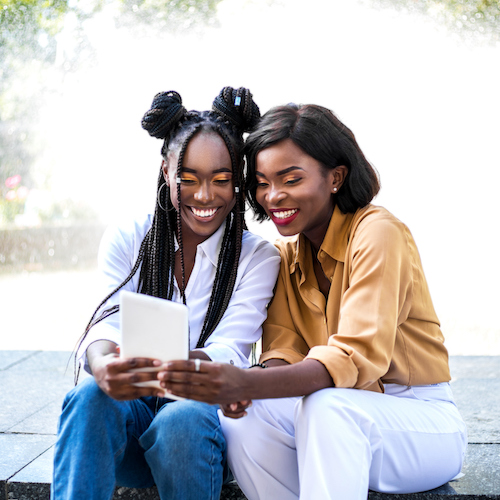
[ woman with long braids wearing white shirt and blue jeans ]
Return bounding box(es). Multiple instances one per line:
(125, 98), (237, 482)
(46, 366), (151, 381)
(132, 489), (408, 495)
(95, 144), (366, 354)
(51, 87), (279, 500)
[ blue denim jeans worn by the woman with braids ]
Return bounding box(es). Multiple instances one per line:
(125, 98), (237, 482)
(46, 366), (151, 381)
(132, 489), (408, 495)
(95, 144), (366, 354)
(51, 377), (228, 500)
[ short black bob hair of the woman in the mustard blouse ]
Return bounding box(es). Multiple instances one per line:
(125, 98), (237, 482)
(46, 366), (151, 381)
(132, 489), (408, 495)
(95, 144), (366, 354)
(245, 104), (380, 221)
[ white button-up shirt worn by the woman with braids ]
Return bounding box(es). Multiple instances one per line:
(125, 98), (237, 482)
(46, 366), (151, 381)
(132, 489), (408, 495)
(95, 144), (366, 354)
(78, 215), (280, 371)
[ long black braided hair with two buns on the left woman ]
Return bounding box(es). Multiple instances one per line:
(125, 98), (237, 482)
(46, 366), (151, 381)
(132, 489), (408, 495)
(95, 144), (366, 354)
(75, 87), (260, 382)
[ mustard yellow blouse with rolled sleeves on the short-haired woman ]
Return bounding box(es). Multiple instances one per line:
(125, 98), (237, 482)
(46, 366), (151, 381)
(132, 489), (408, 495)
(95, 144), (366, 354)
(261, 205), (450, 392)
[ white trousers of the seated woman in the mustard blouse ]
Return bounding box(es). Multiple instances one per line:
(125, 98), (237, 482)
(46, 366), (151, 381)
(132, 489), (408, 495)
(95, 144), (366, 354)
(219, 383), (467, 500)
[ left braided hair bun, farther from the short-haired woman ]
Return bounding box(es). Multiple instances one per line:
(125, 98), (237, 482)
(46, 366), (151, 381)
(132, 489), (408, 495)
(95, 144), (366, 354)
(141, 90), (186, 139)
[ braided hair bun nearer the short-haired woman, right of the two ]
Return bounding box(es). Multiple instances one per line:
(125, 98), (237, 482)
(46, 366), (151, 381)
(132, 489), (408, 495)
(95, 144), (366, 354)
(212, 87), (260, 132)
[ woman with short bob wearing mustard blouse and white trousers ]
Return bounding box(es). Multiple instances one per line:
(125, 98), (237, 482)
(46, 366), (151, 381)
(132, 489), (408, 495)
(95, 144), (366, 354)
(158, 105), (467, 500)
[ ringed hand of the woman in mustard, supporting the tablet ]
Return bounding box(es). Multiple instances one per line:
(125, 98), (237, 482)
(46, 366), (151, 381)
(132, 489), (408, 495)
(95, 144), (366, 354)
(158, 359), (248, 404)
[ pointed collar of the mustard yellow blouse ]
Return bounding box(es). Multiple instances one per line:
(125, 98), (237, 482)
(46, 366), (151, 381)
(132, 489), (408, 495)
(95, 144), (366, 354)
(290, 206), (355, 274)
